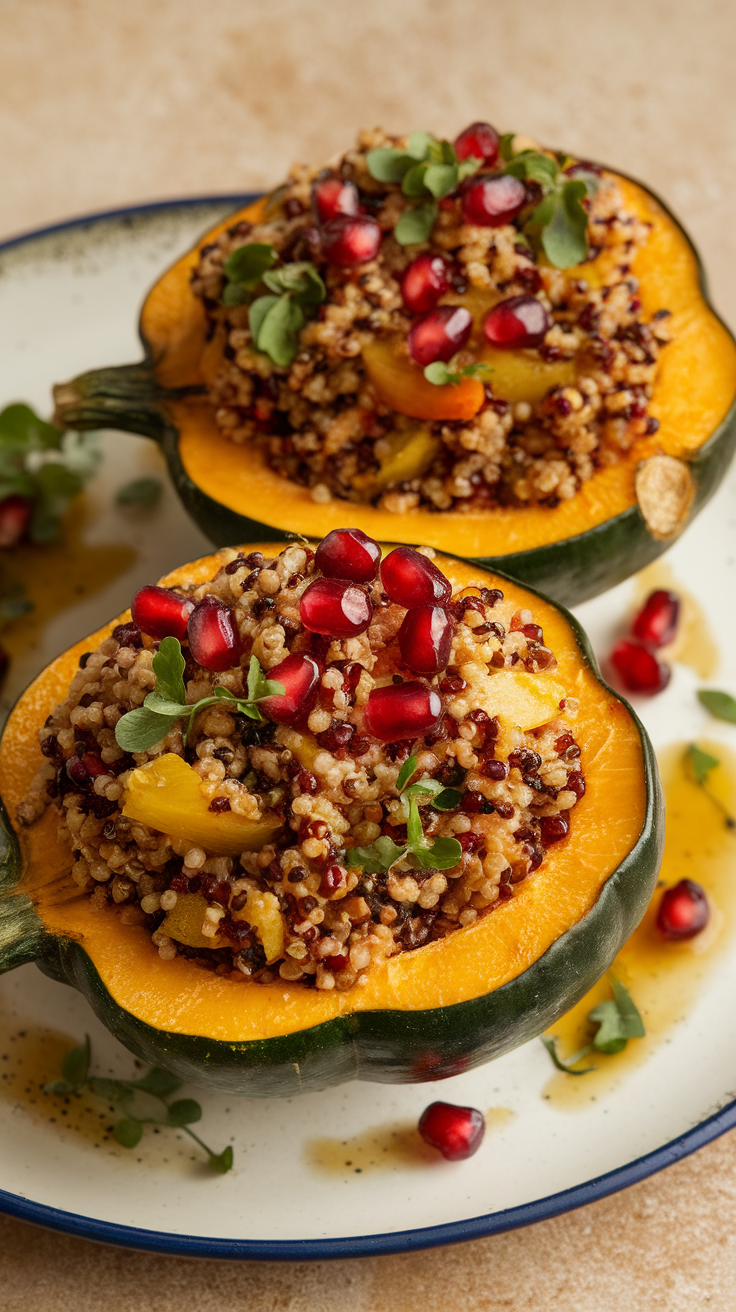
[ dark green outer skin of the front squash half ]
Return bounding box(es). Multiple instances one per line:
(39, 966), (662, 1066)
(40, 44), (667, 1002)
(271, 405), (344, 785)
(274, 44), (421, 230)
(0, 579), (664, 1098)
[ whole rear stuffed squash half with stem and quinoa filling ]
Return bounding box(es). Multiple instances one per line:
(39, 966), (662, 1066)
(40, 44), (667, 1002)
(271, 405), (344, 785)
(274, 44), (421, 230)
(55, 123), (736, 605)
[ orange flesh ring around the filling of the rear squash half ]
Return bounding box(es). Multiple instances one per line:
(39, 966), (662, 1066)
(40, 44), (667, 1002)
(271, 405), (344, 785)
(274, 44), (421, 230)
(142, 176), (736, 561)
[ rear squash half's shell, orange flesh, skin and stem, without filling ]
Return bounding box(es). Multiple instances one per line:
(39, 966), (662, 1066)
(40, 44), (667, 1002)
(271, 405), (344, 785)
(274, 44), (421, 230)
(55, 176), (736, 604)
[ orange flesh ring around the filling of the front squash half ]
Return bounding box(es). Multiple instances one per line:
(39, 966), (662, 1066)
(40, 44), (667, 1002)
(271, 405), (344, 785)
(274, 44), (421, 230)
(0, 546), (648, 1044)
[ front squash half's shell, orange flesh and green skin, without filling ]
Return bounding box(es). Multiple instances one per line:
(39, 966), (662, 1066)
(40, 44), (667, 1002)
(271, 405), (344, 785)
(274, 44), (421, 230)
(0, 547), (664, 1097)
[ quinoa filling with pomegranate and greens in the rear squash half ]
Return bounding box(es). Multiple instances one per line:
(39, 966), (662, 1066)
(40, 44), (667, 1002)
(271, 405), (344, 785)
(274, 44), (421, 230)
(192, 125), (669, 514)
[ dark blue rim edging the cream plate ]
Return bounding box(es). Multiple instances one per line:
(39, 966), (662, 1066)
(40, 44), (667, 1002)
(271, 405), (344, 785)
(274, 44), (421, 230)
(0, 192), (736, 1262)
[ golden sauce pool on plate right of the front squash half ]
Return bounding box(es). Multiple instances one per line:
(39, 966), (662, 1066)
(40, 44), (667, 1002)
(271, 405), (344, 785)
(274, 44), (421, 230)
(544, 739), (736, 1110)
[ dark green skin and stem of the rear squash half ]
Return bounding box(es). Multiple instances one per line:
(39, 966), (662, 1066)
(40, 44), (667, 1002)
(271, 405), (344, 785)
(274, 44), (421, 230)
(54, 173), (736, 606)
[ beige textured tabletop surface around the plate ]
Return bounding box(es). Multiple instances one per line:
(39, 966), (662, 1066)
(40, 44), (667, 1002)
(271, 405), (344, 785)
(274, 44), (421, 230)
(0, 0), (736, 1312)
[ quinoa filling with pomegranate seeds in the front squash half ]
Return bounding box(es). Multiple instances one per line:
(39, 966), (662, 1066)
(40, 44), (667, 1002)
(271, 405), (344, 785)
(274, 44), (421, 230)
(18, 530), (585, 989)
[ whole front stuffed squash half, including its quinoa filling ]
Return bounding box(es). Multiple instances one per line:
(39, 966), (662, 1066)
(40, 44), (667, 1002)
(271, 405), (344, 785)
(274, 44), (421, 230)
(0, 530), (664, 1097)
